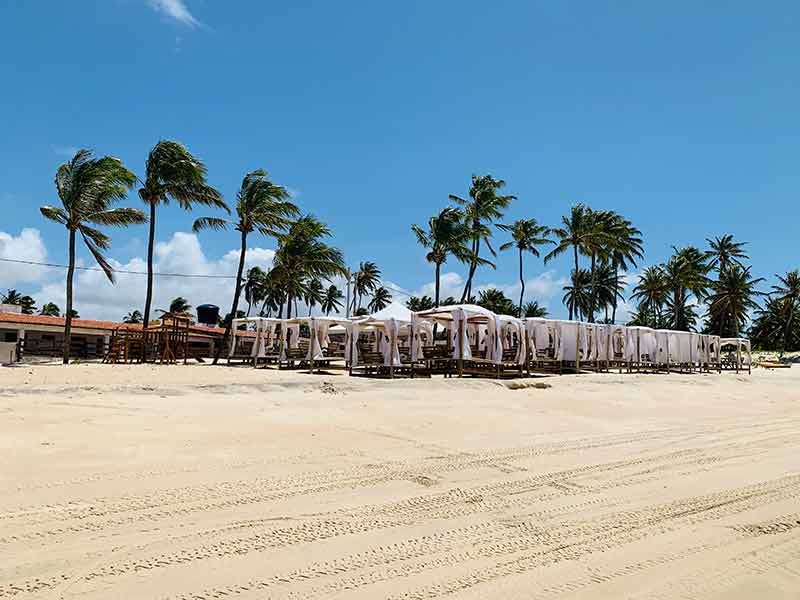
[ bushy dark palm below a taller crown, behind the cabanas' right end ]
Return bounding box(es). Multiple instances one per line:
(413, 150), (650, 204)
(709, 264), (764, 337)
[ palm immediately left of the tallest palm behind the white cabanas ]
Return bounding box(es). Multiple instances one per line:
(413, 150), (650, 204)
(411, 206), (471, 306)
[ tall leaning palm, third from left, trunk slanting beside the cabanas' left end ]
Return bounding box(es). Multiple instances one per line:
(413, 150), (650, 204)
(193, 169), (299, 364)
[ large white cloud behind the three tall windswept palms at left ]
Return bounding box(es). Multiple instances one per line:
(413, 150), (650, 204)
(34, 232), (275, 321)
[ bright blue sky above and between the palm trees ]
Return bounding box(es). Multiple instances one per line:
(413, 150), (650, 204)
(0, 0), (800, 316)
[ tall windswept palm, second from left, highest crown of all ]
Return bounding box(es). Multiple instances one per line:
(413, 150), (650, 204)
(139, 140), (229, 338)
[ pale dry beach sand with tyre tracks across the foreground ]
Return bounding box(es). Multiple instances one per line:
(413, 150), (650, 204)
(0, 365), (800, 600)
